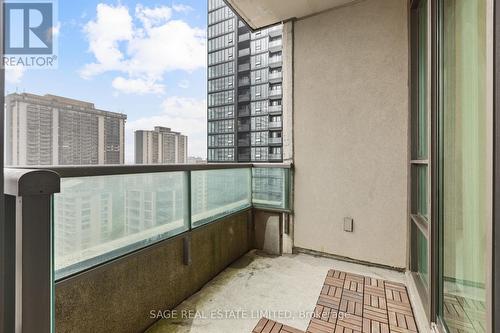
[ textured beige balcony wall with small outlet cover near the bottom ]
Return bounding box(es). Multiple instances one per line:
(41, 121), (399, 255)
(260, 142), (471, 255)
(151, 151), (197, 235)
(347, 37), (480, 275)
(294, 0), (408, 267)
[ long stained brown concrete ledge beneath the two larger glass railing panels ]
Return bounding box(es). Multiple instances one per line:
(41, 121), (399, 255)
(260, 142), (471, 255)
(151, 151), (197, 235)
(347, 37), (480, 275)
(55, 210), (253, 333)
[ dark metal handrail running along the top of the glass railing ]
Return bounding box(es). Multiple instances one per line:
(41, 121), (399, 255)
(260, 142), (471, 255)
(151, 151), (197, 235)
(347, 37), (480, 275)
(5, 163), (293, 178)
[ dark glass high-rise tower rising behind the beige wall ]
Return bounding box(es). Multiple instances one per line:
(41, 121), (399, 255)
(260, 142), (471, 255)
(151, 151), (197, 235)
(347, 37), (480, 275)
(207, 0), (283, 162)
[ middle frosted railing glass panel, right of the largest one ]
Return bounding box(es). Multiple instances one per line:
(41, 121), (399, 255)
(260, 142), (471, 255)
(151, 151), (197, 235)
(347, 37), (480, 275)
(191, 169), (252, 227)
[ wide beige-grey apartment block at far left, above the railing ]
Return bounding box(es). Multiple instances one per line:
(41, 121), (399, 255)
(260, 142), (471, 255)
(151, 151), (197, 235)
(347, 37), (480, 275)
(5, 93), (127, 165)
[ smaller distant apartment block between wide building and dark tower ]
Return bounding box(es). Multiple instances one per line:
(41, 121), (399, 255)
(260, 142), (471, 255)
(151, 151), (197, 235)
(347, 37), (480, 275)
(135, 126), (188, 164)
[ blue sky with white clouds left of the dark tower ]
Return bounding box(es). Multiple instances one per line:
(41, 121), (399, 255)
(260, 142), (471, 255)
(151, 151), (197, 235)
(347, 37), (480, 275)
(6, 0), (207, 163)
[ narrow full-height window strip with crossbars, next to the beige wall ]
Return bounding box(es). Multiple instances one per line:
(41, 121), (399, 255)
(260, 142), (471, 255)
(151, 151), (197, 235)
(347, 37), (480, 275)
(410, 0), (431, 312)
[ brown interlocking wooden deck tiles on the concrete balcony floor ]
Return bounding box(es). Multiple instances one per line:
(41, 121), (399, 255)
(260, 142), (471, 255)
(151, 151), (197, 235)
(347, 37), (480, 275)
(253, 270), (418, 333)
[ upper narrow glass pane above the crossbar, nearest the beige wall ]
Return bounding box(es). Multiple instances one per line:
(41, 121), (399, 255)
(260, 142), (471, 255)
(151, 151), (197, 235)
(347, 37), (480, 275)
(417, 0), (428, 159)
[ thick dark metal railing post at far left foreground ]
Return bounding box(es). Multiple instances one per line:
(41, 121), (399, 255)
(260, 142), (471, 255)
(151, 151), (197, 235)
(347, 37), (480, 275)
(4, 169), (60, 333)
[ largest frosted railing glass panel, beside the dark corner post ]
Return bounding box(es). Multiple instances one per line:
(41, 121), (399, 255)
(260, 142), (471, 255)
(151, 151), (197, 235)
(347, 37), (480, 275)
(54, 172), (189, 279)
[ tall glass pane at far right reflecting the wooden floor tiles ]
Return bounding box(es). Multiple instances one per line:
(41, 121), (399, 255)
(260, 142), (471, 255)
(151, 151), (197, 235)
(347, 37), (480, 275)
(440, 0), (491, 332)
